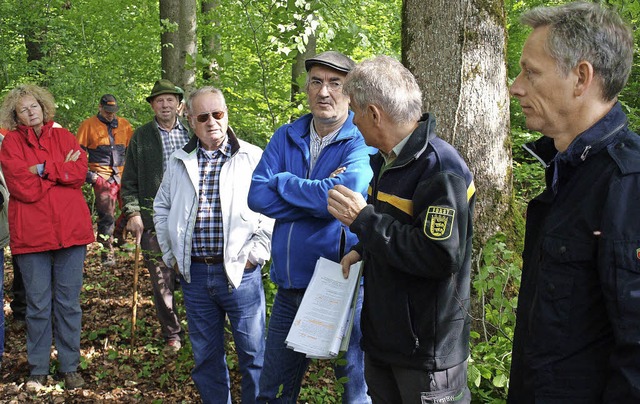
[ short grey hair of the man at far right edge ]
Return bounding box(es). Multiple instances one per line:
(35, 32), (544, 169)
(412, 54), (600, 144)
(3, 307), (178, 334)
(520, 2), (633, 101)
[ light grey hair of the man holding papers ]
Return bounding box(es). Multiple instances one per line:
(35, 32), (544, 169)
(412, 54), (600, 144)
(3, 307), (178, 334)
(342, 56), (422, 123)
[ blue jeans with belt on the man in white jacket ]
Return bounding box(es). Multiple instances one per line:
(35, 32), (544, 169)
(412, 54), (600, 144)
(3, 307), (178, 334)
(181, 263), (265, 404)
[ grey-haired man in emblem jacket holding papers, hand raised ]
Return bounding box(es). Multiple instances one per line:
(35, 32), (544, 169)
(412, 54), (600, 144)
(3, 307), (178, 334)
(328, 56), (475, 403)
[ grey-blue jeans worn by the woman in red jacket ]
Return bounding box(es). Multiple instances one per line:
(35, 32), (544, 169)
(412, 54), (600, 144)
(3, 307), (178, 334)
(15, 245), (87, 375)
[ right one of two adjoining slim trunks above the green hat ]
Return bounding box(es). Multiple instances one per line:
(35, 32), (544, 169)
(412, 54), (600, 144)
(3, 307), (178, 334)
(176, 0), (198, 95)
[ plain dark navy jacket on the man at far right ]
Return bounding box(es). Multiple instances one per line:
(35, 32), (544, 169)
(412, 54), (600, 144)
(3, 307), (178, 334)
(509, 104), (640, 403)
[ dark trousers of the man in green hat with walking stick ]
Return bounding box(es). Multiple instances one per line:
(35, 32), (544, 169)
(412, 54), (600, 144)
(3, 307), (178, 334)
(140, 230), (183, 341)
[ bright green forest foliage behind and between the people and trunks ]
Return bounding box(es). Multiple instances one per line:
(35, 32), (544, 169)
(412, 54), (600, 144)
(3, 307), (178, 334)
(0, 0), (640, 402)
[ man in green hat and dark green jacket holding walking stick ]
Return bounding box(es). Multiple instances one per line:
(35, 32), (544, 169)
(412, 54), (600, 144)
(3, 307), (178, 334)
(121, 79), (189, 353)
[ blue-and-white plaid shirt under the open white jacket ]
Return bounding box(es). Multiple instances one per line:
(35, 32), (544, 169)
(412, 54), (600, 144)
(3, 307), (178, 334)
(191, 140), (231, 257)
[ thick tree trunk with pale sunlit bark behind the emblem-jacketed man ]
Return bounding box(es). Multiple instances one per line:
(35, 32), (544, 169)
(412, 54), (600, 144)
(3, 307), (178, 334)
(402, 0), (514, 248)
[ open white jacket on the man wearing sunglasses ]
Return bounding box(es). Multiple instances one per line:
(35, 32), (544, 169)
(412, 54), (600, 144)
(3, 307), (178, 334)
(153, 132), (274, 288)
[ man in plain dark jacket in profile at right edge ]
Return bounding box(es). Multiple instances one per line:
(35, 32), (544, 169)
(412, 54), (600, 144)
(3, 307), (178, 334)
(508, 3), (640, 403)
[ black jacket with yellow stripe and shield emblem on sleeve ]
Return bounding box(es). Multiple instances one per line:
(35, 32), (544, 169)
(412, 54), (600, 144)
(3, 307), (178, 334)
(350, 115), (475, 371)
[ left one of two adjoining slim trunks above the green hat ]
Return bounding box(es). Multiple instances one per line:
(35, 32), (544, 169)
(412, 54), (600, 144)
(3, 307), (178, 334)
(160, 0), (182, 86)
